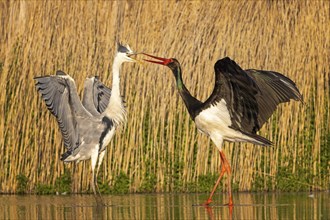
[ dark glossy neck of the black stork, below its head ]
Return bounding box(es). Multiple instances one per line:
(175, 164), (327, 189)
(172, 66), (202, 119)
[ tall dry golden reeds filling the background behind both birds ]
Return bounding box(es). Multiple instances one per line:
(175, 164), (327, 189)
(0, 1), (330, 192)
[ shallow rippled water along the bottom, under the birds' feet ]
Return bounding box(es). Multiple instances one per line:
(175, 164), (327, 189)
(0, 192), (330, 219)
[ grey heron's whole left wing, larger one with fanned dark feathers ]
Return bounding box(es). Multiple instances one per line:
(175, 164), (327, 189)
(34, 71), (89, 149)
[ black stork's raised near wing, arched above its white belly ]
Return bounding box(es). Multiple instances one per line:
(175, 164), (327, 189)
(205, 57), (260, 133)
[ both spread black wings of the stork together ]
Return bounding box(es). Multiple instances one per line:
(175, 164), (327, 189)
(205, 57), (300, 133)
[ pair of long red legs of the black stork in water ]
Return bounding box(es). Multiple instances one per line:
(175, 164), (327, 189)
(204, 151), (233, 206)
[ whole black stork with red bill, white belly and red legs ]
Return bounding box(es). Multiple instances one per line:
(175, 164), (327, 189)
(144, 53), (302, 206)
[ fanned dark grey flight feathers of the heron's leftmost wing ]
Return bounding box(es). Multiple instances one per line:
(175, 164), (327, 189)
(34, 76), (78, 148)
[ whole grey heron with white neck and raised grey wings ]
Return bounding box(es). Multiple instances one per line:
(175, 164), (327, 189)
(35, 44), (137, 203)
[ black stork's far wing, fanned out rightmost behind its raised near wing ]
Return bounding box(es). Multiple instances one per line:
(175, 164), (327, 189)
(245, 69), (302, 127)
